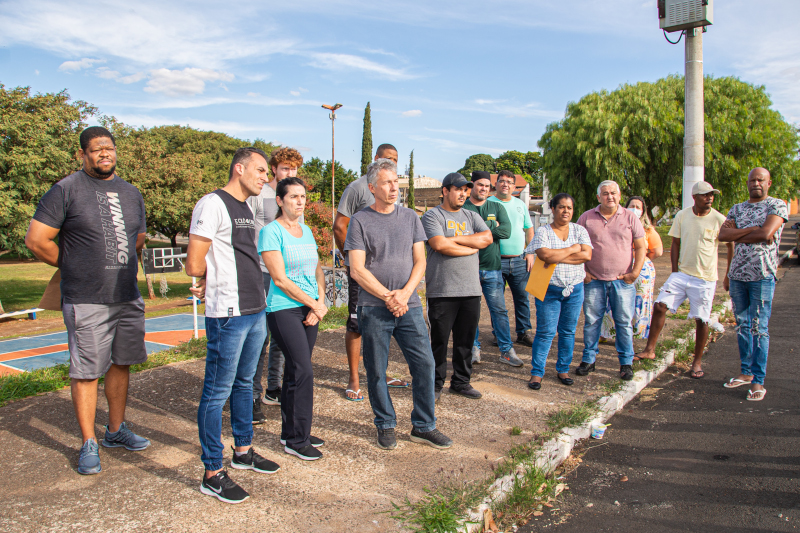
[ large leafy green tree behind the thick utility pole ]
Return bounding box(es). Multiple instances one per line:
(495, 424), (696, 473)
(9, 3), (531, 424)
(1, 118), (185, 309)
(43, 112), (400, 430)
(539, 76), (800, 213)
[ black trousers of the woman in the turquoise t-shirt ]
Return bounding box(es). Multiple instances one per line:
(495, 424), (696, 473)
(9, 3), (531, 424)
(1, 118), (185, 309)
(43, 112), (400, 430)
(267, 306), (319, 450)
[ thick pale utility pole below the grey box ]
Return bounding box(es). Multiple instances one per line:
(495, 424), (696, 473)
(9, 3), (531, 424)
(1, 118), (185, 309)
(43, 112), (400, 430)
(683, 28), (705, 209)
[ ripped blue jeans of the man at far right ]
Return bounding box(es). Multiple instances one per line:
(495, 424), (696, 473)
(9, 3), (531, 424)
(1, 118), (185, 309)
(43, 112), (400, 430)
(730, 277), (775, 385)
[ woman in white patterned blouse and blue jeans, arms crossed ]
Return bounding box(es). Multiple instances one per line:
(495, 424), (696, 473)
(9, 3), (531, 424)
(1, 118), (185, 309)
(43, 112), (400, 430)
(525, 192), (592, 390)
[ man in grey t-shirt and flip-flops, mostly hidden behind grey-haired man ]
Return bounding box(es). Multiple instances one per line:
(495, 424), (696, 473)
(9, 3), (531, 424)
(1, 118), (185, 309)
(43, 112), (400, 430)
(333, 144), (408, 402)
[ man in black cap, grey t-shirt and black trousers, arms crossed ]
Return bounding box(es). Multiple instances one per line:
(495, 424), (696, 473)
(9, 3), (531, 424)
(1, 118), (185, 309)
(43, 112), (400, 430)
(422, 172), (492, 401)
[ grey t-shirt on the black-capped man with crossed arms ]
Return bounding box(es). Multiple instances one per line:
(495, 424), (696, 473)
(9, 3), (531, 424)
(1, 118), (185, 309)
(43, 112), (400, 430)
(422, 205), (489, 298)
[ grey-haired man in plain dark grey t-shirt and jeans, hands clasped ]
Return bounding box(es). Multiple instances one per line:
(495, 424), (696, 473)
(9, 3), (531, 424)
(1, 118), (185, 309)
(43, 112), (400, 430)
(344, 159), (452, 450)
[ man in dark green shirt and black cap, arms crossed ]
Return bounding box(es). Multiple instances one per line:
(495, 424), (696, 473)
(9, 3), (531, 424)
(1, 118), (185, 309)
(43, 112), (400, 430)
(464, 170), (522, 366)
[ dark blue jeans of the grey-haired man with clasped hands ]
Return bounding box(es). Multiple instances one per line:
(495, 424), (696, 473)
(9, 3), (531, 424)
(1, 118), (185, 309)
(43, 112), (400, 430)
(358, 306), (436, 431)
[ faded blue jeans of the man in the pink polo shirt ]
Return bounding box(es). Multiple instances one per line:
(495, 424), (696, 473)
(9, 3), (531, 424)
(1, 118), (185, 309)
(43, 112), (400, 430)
(583, 279), (636, 366)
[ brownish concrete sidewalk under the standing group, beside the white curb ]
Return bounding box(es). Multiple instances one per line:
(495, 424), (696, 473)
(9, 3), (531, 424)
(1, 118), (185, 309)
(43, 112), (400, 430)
(0, 257), (732, 532)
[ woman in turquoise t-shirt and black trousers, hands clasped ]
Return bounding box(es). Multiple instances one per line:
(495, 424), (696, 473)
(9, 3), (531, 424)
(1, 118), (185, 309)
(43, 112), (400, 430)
(258, 178), (328, 461)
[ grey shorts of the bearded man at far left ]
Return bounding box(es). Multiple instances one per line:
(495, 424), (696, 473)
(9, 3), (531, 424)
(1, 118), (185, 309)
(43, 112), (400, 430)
(61, 297), (147, 379)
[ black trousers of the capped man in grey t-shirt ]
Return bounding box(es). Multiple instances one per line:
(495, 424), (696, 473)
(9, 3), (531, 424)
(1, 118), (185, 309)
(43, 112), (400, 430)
(428, 296), (481, 390)
